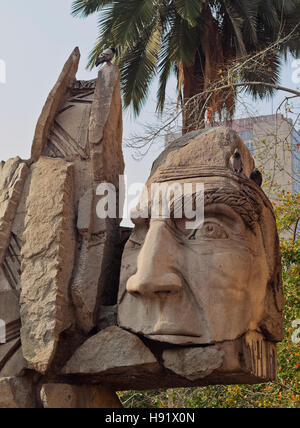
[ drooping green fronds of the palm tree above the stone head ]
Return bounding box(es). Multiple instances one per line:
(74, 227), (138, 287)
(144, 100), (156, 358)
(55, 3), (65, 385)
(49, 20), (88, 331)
(72, 0), (300, 131)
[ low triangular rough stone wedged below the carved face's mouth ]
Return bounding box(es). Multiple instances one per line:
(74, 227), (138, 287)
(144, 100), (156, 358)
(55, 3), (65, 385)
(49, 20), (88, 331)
(63, 327), (160, 375)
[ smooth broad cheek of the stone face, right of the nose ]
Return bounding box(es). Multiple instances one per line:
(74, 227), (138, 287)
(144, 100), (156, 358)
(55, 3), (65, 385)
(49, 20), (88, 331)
(182, 243), (266, 341)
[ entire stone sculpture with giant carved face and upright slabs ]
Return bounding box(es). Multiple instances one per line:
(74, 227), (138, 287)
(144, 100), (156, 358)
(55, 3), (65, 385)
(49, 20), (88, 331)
(0, 49), (283, 408)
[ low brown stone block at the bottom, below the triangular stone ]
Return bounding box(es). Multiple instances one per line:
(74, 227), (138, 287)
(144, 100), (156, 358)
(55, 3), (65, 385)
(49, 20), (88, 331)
(41, 384), (122, 409)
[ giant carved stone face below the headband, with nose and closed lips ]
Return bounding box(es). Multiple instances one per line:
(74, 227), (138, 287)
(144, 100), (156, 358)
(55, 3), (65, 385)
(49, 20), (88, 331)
(118, 126), (280, 345)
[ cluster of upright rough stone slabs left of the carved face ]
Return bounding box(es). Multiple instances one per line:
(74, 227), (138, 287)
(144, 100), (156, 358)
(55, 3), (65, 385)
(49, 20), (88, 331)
(0, 48), (124, 407)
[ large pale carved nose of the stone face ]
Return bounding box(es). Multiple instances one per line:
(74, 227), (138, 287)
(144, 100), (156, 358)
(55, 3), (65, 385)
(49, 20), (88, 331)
(126, 220), (183, 297)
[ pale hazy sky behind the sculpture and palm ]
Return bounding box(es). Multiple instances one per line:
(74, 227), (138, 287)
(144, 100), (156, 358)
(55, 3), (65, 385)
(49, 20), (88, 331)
(0, 0), (296, 208)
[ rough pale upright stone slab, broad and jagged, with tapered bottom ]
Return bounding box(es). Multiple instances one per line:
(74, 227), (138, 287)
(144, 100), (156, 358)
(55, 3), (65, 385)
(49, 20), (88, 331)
(21, 158), (75, 373)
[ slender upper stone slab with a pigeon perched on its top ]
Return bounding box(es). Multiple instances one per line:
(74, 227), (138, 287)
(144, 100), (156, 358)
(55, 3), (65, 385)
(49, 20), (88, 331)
(89, 65), (124, 188)
